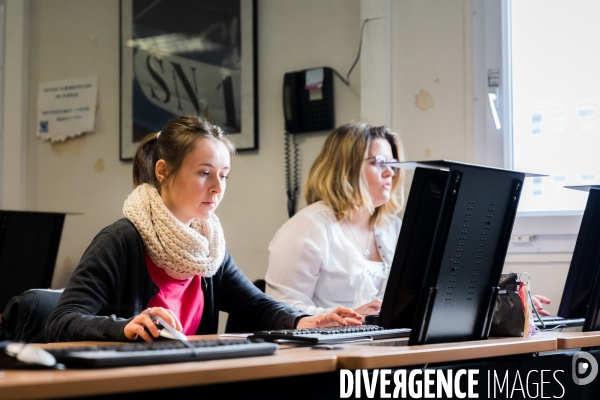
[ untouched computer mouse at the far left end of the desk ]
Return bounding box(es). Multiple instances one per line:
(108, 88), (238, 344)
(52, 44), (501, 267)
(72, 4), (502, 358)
(0, 340), (59, 368)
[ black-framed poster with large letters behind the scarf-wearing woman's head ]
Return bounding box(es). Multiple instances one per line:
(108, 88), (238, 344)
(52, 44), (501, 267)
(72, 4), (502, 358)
(119, 0), (258, 161)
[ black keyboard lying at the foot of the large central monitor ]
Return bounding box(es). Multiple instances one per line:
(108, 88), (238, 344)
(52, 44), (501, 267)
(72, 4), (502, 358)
(249, 325), (410, 344)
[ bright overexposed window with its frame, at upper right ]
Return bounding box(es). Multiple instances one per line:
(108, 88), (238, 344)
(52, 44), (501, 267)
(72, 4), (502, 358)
(473, 0), (600, 215)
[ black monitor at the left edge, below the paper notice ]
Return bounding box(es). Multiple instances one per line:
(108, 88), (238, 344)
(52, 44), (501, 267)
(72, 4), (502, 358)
(0, 210), (65, 313)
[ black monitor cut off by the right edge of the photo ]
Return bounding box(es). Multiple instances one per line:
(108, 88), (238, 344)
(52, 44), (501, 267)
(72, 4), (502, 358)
(558, 185), (600, 332)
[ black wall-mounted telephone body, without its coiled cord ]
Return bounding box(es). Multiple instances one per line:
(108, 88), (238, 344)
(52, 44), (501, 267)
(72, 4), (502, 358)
(283, 67), (335, 133)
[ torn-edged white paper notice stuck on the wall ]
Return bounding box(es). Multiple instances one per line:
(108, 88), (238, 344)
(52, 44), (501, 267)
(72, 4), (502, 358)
(37, 76), (98, 142)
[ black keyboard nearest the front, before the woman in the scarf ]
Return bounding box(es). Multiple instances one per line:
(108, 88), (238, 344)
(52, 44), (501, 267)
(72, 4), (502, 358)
(48, 339), (277, 368)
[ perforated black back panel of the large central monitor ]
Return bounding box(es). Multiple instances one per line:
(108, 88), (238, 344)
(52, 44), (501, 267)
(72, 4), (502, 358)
(411, 165), (525, 344)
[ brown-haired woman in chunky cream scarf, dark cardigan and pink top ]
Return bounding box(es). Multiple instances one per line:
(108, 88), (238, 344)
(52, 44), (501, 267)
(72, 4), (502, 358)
(46, 116), (362, 342)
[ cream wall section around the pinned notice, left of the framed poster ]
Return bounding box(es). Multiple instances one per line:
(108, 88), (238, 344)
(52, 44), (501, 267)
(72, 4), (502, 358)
(27, 0), (132, 287)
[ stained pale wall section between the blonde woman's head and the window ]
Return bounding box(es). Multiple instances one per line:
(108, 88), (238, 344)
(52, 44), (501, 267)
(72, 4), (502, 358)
(392, 0), (473, 162)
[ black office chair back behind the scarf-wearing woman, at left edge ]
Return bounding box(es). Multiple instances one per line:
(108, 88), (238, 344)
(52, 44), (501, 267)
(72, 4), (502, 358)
(0, 289), (62, 343)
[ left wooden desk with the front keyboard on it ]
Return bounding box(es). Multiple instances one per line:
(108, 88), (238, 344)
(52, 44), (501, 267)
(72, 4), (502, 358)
(0, 348), (336, 399)
